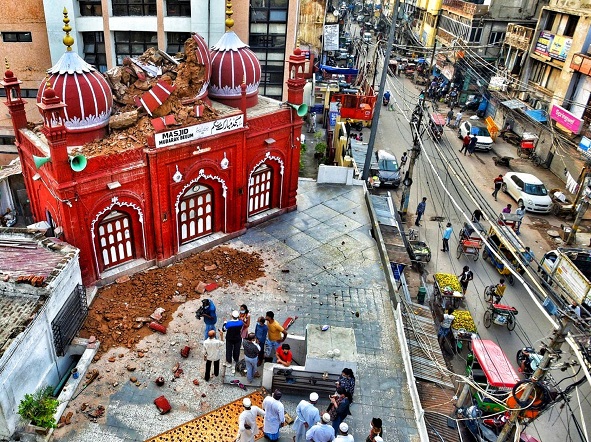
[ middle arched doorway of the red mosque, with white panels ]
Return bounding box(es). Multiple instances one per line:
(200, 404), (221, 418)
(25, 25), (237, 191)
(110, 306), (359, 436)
(178, 184), (213, 244)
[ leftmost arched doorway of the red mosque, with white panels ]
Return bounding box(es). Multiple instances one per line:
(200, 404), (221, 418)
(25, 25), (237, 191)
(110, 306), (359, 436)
(97, 210), (135, 270)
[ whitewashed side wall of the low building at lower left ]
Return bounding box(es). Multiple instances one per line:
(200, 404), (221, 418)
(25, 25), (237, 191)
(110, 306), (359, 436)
(0, 248), (82, 438)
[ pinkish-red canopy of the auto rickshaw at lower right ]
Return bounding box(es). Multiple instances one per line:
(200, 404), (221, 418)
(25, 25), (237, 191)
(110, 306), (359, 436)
(472, 339), (519, 388)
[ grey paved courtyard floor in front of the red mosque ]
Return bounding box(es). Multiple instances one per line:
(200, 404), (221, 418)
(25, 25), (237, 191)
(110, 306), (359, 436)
(54, 179), (418, 442)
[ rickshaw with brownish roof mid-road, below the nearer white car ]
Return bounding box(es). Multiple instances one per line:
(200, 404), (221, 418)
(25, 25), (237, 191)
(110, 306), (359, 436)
(482, 224), (525, 285)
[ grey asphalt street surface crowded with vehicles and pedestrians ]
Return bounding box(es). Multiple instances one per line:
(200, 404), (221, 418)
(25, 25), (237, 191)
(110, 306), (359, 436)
(372, 76), (591, 441)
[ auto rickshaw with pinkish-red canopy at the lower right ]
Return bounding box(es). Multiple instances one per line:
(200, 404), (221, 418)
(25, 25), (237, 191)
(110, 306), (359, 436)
(465, 339), (520, 413)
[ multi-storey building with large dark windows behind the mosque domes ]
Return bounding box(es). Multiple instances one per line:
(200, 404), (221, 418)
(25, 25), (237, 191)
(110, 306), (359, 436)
(0, 0), (298, 99)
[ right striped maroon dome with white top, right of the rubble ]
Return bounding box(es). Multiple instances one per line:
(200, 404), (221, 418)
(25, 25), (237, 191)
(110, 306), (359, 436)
(209, 31), (261, 107)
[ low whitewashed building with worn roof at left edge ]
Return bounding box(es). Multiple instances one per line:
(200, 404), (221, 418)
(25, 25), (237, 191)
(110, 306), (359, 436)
(0, 229), (82, 439)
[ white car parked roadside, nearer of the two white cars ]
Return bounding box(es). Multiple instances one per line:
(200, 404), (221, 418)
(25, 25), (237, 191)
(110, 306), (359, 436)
(501, 172), (552, 213)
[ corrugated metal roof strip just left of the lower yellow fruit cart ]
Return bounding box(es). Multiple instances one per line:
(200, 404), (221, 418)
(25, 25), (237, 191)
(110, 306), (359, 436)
(402, 304), (453, 388)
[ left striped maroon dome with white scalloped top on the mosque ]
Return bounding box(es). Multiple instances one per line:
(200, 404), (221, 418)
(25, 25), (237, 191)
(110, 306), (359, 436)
(37, 51), (113, 135)
